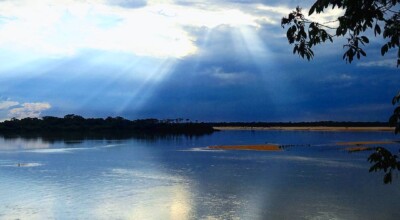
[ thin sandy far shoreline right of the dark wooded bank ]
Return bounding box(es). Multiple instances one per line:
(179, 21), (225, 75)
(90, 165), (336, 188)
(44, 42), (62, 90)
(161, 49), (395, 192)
(213, 126), (394, 132)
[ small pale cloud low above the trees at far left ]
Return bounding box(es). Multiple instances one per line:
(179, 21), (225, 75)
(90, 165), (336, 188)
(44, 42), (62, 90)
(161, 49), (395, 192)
(8, 102), (51, 119)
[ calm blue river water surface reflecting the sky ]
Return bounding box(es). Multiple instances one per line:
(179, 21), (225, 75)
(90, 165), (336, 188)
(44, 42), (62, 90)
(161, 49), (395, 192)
(0, 131), (400, 219)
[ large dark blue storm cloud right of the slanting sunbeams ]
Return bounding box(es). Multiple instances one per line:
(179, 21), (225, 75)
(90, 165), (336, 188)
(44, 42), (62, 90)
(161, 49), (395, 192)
(130, 19), (400, 121)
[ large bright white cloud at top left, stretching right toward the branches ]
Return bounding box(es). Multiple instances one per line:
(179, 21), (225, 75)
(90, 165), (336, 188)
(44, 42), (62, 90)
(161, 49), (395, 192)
(0, 0), (285, 58)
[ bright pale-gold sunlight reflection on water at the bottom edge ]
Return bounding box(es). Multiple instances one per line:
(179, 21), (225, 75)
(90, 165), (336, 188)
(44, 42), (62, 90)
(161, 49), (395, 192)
(92, 180), (192, 220)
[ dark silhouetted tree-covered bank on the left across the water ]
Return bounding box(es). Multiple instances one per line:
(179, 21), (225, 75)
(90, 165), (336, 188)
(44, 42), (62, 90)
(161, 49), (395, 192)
(0, 114), (214, 135)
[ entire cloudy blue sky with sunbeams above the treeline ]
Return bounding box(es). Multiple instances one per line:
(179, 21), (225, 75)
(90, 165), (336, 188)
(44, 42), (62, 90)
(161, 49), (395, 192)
(0, 0), (400, 122)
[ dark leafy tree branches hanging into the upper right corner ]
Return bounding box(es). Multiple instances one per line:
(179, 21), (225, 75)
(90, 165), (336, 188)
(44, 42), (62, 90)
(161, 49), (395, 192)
(281, 0), (400, 66)
